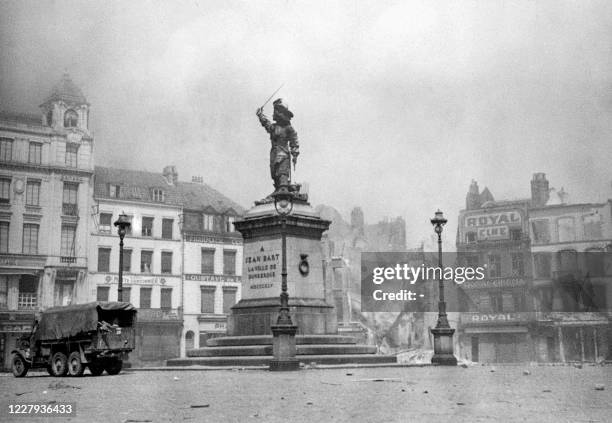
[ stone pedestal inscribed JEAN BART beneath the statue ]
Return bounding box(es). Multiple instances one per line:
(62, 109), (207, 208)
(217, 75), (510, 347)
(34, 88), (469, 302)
(228, 199), (338, 336)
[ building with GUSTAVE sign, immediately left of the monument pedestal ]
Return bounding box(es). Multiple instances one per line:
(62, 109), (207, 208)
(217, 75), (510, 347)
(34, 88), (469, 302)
(179, 178), (244, 357)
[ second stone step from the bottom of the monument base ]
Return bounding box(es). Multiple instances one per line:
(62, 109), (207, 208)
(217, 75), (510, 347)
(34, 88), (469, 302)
(187, 344), (376, 357)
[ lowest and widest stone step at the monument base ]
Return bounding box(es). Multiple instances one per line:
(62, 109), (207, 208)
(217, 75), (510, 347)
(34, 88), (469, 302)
(166, 354), (397, 367)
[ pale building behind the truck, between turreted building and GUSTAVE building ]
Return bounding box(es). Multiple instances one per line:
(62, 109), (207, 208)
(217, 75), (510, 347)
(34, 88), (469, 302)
(88, 166), (183, 365)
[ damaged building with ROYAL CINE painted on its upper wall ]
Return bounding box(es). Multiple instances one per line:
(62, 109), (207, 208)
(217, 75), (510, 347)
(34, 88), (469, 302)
(456, 181), (533, 363)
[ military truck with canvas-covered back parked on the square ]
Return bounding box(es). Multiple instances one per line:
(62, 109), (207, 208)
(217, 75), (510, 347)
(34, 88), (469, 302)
(12, 302), (136, 377)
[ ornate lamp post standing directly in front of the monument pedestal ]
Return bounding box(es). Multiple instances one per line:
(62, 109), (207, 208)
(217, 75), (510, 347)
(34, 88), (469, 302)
(270, 185), (300, 371)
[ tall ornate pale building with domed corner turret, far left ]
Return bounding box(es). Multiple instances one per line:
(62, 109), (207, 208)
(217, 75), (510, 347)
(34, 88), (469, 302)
(0, 74), (93, 369)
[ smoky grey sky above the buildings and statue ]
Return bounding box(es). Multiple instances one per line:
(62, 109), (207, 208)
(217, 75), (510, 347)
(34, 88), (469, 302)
(0, 0), (612, 246)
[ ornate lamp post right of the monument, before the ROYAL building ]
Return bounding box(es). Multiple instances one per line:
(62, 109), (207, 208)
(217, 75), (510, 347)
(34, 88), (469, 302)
(431, 210), (457, 366)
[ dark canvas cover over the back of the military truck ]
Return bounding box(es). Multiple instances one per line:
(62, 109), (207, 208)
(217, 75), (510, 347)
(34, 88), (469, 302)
(34, 301), (136, 340)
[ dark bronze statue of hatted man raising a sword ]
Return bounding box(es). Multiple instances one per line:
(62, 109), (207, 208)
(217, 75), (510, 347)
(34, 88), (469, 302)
(256, 98), (300, 191)
